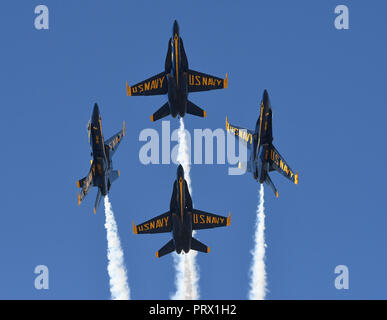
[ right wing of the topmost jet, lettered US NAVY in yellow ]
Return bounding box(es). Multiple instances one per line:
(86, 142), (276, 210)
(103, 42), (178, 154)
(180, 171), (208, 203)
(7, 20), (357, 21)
(188, 70), (228, 92)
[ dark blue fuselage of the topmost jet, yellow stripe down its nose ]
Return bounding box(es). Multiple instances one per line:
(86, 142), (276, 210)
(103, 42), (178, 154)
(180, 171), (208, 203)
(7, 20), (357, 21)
(165, 21), (188, 118)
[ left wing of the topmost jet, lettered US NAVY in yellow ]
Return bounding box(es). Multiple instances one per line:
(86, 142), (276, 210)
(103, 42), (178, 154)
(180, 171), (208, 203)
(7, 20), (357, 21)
(126, 72), (168, 96)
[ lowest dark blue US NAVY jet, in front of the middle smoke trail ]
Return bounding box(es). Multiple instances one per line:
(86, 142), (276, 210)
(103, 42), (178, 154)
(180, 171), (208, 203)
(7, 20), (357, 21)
(133, 165), (231, 258)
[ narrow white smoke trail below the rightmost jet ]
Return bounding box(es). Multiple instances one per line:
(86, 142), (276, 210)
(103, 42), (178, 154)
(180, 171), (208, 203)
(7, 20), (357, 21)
(249, 184), (267, 300)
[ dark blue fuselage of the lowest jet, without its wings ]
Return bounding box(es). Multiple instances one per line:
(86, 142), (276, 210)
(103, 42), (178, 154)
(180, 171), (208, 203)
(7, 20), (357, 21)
(170, 169), (192, 253)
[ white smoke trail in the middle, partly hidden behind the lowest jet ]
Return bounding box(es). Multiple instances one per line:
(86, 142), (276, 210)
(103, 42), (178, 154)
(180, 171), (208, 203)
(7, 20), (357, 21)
(171, 118), (199, 300)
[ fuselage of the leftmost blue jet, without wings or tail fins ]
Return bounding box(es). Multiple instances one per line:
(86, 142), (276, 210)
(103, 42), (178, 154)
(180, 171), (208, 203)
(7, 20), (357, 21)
(89, 105), (112, 196)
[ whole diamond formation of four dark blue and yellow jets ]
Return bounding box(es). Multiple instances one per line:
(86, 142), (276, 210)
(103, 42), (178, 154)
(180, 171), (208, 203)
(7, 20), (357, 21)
(77, 20), (298, 258)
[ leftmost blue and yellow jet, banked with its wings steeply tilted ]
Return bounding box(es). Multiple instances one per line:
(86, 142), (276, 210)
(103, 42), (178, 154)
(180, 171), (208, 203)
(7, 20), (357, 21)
(77, 104), (125, 214)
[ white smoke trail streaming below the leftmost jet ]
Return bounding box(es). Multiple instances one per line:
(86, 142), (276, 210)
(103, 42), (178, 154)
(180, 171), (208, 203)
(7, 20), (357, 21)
(105, 196), (130, 300)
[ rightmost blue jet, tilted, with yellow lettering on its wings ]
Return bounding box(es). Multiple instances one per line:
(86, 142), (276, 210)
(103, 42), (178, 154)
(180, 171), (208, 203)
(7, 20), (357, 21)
(226, 90), (298, 198)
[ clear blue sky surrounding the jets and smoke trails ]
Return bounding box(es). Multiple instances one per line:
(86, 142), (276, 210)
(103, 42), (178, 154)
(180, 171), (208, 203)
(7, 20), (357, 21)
(0, 0), (387, 299)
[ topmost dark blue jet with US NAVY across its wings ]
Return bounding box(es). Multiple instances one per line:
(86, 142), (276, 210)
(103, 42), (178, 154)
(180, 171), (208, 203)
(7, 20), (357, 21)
(126, 20), (228, 121)
